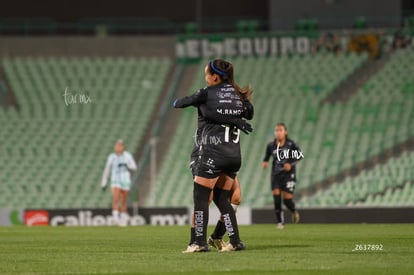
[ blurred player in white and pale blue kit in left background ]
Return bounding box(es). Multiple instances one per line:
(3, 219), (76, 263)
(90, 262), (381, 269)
(101, 140), (137, 226)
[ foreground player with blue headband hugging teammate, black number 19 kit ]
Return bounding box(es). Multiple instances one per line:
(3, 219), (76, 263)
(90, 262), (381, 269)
(174, 60), (252, 252)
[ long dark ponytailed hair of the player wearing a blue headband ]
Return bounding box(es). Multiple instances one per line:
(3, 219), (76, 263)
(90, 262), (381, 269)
(207, 59), (253, 102)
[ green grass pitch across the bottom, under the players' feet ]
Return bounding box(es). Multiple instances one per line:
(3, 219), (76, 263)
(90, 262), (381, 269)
(0, 224), (414, 275)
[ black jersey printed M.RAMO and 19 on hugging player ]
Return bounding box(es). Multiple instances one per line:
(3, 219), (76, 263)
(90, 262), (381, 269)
(174, 83), (246, 161)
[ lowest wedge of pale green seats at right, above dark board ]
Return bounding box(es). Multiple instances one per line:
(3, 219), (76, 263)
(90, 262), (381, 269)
(300, 152), (414, 207)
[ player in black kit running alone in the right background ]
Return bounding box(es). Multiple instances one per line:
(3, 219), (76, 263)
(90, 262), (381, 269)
(263, 123), (303, 229)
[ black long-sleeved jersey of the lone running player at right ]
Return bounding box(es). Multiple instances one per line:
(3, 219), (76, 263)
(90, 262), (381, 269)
(263, 139), (303, 175)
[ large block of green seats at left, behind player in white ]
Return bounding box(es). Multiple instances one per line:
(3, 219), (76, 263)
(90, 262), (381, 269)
(0, 57), (171, 209)
